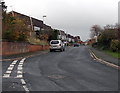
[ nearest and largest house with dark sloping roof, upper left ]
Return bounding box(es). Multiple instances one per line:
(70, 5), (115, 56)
(9, 11), (52, 36)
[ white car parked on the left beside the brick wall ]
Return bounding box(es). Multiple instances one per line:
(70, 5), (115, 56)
(50, 40), (65, 52)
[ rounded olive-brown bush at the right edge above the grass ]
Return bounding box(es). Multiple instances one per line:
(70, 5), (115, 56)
(110, 40), (120, 52)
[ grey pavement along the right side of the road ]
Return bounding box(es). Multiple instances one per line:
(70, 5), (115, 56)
(89, 46), (119, 65)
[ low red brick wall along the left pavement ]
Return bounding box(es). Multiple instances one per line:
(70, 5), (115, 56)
(0, 42), (49, 55)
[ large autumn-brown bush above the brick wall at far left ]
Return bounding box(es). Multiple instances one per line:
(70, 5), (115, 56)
(2, 14), (31, 41)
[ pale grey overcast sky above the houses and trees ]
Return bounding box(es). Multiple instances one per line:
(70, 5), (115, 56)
(4, 0), (120, 40)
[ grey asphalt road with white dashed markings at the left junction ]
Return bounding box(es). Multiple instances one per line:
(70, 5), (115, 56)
(2, 46), (118, 91)
